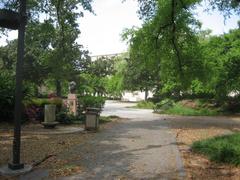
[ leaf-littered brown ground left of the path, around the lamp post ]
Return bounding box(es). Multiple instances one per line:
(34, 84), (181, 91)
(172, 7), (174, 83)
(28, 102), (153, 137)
(0, 118), (120, 180)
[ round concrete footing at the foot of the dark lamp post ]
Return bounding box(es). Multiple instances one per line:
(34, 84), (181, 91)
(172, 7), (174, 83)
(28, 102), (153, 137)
(0, 165), (32, 176)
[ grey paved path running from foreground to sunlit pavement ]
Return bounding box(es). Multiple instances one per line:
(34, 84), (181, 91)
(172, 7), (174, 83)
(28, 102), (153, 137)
(61, 101), (185, 179)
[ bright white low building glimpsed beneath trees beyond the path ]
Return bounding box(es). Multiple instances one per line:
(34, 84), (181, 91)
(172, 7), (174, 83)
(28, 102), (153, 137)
(121, 91), (153, 102)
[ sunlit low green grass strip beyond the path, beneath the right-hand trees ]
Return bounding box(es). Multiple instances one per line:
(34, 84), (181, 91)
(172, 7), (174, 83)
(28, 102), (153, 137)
(161, 103), (219, 116)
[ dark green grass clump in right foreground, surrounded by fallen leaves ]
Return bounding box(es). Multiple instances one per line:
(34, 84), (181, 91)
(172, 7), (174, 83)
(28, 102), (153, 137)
(192, 133), (240, 166)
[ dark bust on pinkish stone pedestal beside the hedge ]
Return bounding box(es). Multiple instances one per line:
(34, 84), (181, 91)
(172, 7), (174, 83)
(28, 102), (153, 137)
(67, 81), (78, 116)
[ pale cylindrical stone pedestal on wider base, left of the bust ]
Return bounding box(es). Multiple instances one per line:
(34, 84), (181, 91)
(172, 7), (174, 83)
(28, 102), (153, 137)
(42, 104), (58, 128)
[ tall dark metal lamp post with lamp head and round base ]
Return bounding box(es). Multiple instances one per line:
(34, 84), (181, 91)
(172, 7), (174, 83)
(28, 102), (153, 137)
(0, 0), (31, 175)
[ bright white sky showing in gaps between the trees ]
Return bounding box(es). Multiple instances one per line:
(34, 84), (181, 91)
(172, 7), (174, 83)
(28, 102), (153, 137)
(0, 0), (239, 56)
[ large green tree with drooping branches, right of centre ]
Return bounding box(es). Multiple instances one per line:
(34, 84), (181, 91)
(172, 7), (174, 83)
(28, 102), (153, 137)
(123, 0), (205, 96)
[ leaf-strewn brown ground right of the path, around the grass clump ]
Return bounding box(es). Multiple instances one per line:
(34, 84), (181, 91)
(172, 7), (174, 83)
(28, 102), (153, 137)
(166, 116), (240, 180)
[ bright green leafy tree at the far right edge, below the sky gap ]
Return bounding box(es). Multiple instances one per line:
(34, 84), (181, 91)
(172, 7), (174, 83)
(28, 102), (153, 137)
(203, 29), (240, 101)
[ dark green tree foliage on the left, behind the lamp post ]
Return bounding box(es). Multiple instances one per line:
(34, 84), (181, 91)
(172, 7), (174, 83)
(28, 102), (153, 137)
(0, 0), (93, 96)
